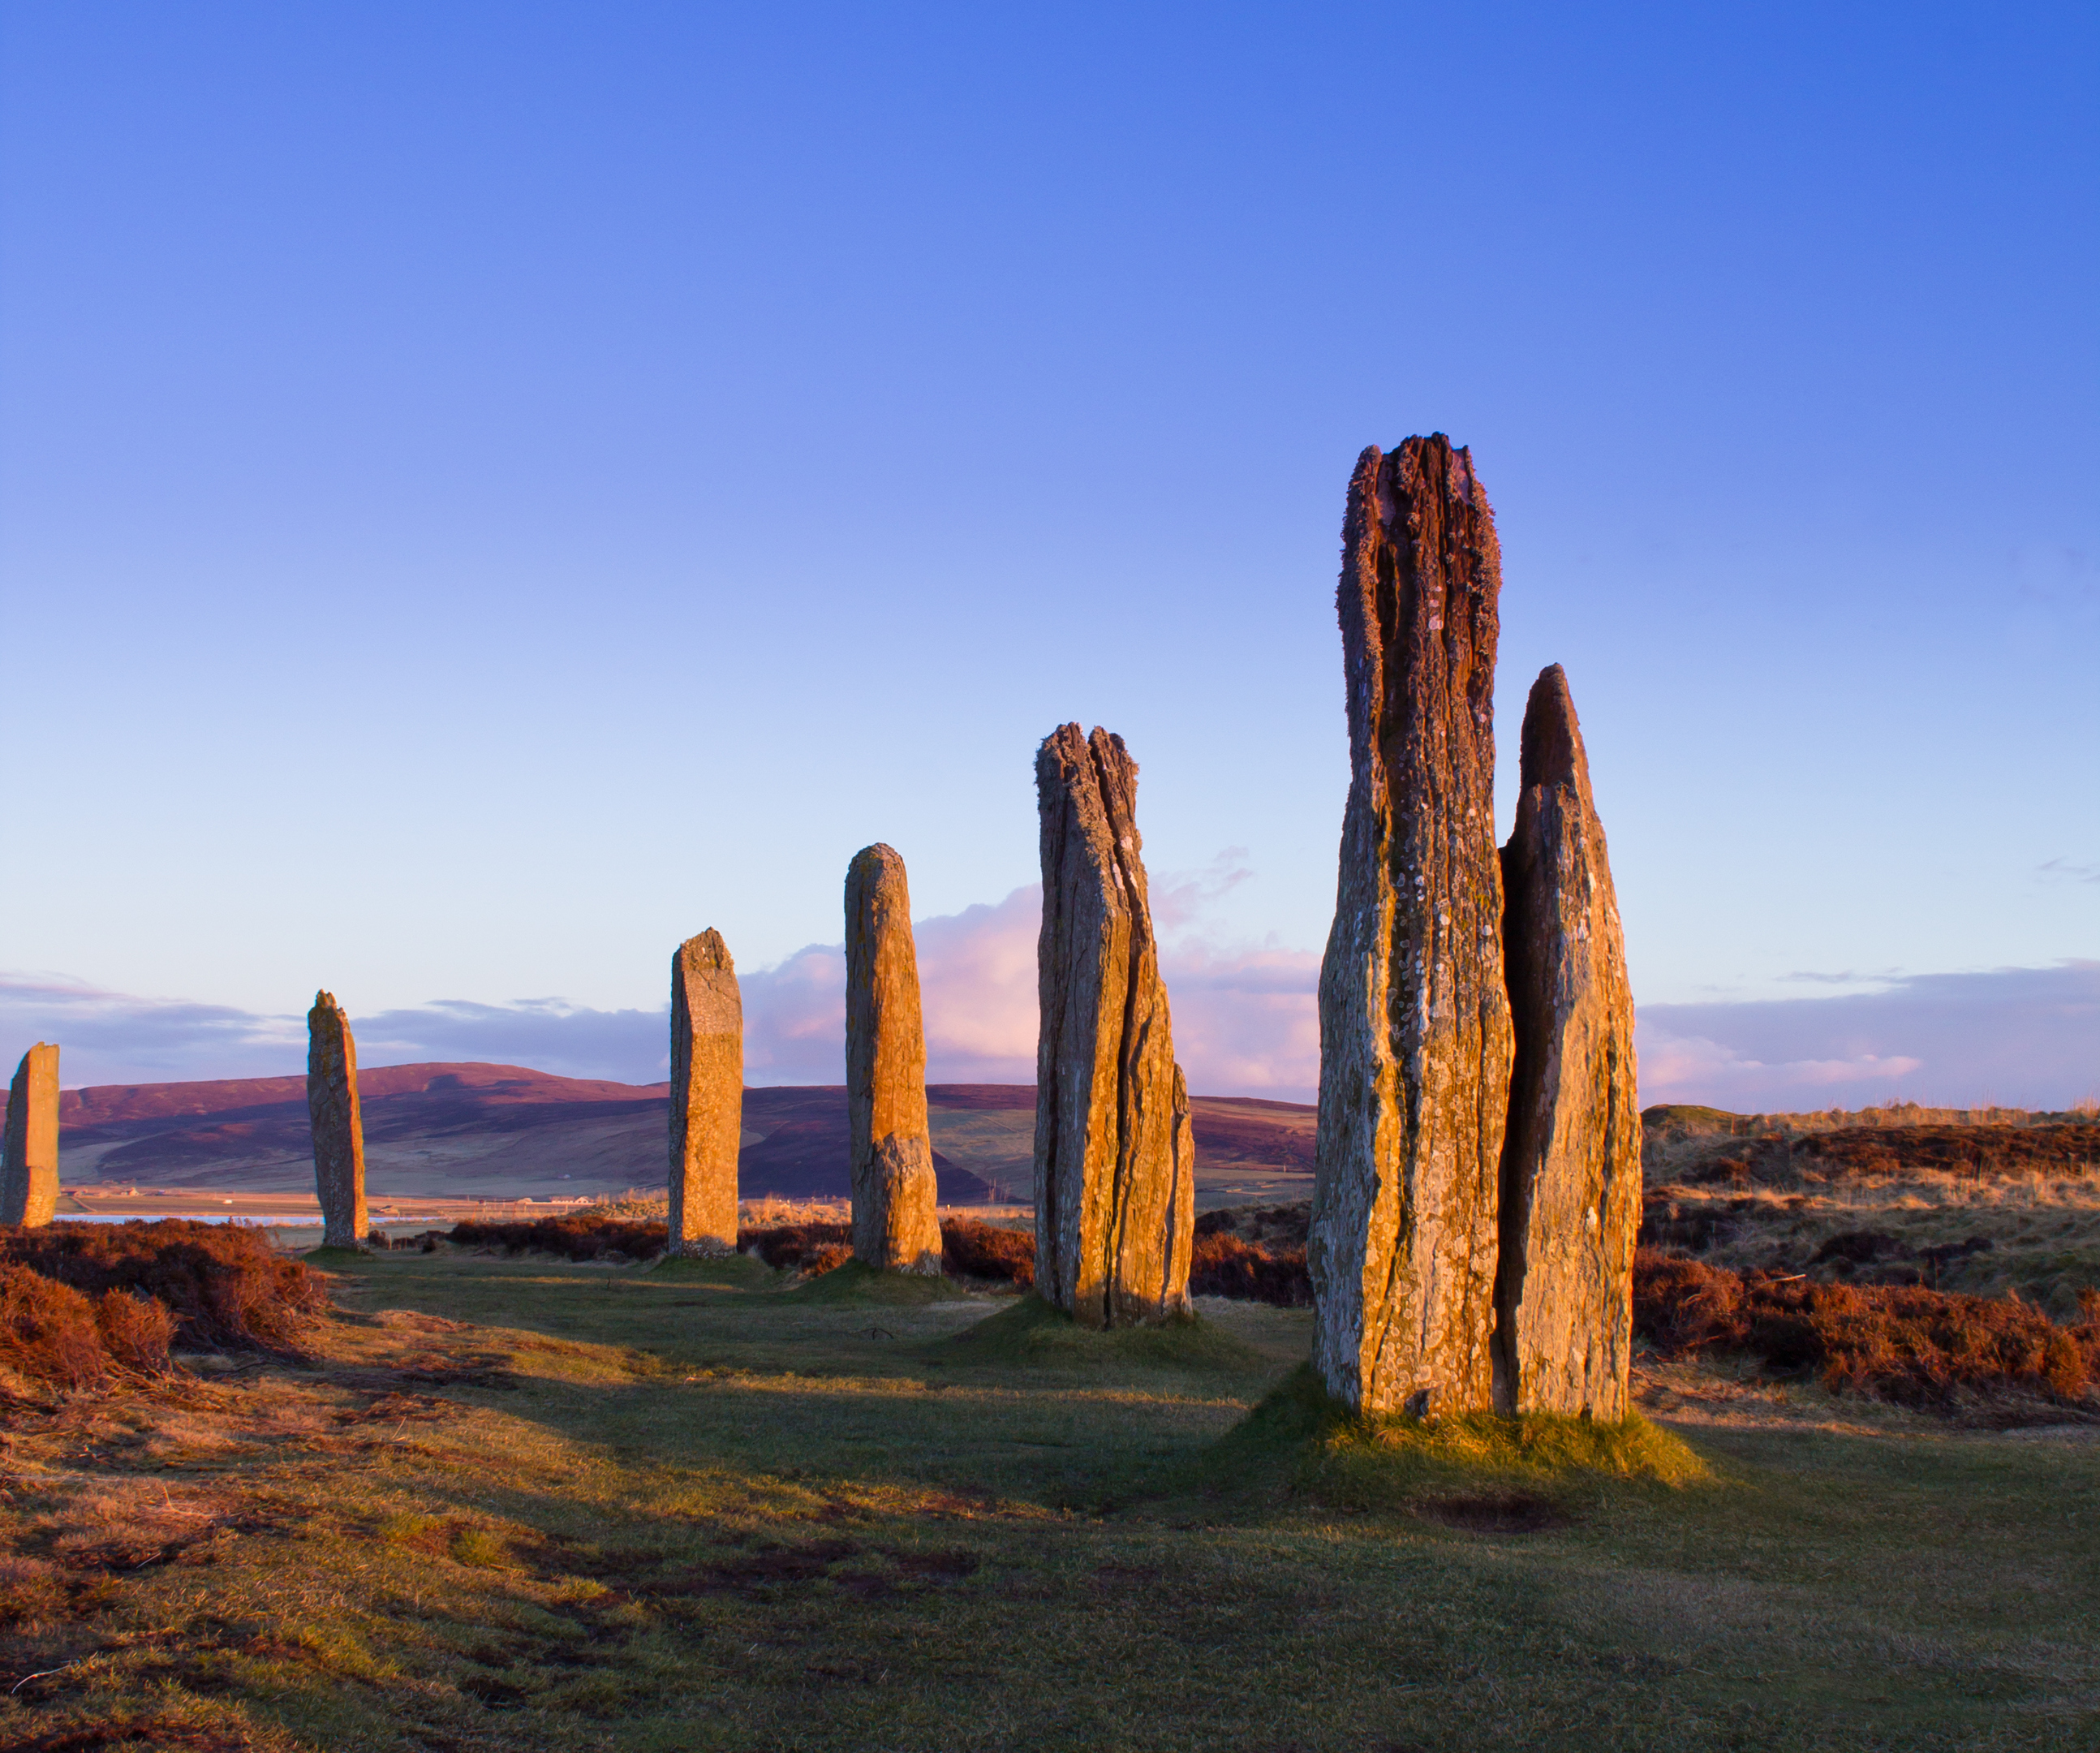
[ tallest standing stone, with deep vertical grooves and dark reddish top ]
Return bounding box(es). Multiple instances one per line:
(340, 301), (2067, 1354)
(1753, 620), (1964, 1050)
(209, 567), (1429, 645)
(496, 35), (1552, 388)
(1306, 434), (1510, 1415)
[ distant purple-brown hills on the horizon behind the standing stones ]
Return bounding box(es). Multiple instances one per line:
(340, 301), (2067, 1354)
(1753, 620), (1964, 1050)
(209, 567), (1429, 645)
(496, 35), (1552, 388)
(58, 1065), (1315, 1203)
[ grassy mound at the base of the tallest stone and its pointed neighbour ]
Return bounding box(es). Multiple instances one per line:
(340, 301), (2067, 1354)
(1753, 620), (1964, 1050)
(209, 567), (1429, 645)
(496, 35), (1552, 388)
(1203, 1364), (1711, 1528)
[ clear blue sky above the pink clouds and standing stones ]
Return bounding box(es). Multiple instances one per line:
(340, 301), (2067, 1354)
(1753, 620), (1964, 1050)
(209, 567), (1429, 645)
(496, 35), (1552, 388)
(0, 4), (2100, 1105)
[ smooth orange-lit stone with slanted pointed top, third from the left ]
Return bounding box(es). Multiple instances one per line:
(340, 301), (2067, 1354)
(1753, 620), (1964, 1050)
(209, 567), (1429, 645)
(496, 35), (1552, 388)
(670, 930), (743, 1253)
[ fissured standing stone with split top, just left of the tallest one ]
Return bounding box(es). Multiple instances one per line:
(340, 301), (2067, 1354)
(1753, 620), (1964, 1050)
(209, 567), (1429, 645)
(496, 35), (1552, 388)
(1035, 724), (1195, 1327)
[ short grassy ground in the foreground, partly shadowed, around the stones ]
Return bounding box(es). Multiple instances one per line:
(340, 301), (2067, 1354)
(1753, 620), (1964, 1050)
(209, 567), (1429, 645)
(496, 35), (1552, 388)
(0, 1253), (2100, 1753)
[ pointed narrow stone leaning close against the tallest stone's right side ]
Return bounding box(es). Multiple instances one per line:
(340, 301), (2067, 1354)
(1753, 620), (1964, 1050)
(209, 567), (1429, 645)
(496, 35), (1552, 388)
(1495, 663), (1640, 1421)
